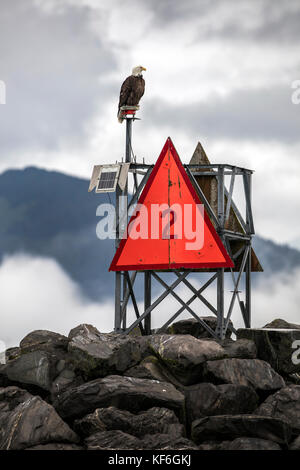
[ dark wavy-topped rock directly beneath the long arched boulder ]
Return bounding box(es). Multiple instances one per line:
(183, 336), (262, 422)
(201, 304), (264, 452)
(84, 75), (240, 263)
(74, 406), (184, 438)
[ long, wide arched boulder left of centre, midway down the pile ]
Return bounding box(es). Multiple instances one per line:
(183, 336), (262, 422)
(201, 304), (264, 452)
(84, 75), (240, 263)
(54, 375), (184, 419)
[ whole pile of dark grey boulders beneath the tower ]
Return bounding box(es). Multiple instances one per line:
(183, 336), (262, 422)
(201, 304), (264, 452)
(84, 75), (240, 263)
(0, 317), (300, 450)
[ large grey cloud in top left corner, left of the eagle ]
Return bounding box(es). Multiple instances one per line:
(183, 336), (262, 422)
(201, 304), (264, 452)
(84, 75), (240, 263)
(0, 0), (116, 155)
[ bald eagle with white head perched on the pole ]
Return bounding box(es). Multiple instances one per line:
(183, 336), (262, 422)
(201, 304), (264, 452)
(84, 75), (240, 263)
(118, 65), (146, 122)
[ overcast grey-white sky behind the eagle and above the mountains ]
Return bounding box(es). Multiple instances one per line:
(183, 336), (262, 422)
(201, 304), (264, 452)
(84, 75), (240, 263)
(0, 0), (300, 341)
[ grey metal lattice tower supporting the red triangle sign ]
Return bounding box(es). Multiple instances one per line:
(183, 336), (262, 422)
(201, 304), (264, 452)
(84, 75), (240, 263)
(91, 114), (262, 339)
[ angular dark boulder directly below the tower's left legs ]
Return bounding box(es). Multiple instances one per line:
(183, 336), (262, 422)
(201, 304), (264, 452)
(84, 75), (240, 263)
(68, 325), (141, 380)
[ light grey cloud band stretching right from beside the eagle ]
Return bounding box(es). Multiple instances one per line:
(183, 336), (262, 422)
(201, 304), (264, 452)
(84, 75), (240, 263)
(147, 87), (300, 143)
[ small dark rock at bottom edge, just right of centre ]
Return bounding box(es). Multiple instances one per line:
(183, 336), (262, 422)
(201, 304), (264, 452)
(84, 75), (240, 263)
(141, 434), (198, 450)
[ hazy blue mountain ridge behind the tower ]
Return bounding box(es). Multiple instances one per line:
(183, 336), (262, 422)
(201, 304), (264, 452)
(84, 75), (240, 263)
(0, 167), (300, 299)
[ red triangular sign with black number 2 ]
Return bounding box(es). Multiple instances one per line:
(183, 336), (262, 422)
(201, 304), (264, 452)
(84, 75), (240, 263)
(109, 138), (233, 271)
